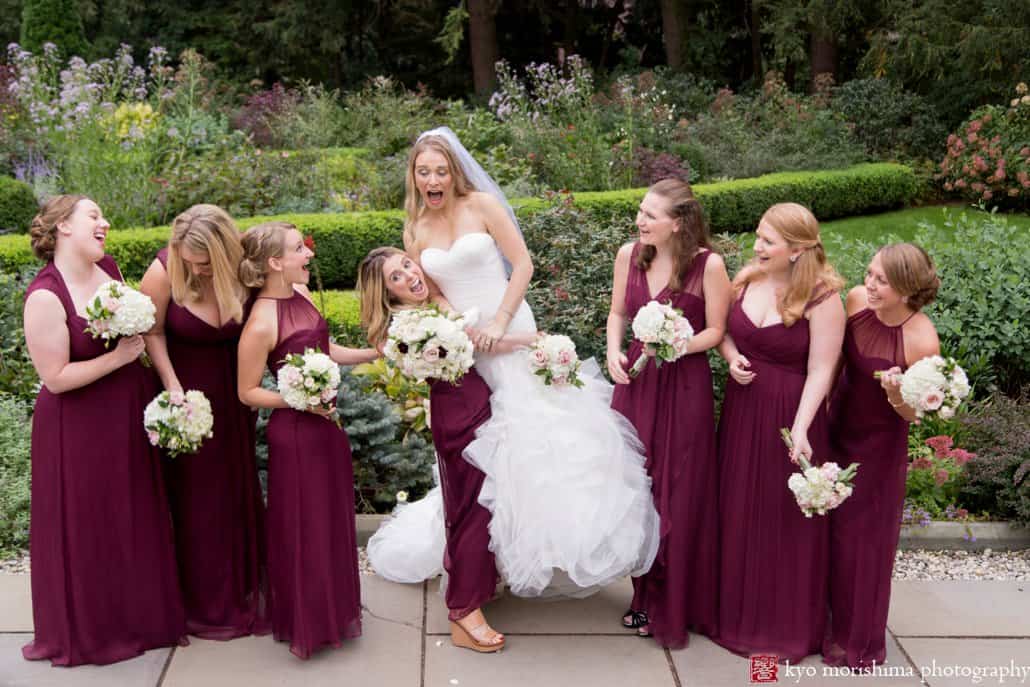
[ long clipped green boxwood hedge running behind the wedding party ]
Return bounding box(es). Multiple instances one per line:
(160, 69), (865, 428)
(0, 164), (917, 286)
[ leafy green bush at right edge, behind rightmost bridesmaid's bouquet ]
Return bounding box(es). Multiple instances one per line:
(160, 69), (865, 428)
(916, 212), (1030, 393)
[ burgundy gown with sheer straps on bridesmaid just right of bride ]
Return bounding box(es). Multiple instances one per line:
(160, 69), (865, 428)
(612, 244), (719, 649)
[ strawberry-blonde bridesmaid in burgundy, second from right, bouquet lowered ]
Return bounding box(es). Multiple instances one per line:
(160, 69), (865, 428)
(715, 203), (845, 662)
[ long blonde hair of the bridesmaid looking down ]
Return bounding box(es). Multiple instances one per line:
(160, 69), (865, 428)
(168, 204), (247, 322)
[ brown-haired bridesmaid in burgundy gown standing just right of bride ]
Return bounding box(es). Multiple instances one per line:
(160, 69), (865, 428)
(608, 179), (732, 649)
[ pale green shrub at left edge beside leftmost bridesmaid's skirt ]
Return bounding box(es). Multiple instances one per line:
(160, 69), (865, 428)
(0, 393), (32, 558)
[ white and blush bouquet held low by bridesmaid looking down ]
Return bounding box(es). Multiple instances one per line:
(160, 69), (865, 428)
(143, 391), (214, 457)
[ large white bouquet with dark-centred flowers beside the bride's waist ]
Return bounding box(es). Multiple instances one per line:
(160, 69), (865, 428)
(383, 306), (473, 383)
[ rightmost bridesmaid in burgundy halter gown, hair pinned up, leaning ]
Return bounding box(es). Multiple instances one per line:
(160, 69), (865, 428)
(823, 243), (940, 668)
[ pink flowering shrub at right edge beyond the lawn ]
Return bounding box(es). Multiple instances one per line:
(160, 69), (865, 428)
(936, 83), (1030, 208)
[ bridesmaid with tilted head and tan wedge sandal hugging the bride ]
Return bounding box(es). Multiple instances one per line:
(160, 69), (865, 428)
(357, 247), (535, 652)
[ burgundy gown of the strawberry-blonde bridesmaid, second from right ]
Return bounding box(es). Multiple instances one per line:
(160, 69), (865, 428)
(715, 287), (836, 662)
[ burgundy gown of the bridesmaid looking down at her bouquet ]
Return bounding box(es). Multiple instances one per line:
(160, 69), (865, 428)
(158, 248), (268, 640)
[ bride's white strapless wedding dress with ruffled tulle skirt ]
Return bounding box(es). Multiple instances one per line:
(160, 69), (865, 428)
(369, 233), (658, 596)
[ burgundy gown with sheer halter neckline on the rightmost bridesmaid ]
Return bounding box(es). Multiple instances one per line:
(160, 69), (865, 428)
(823, 310), (908, 668)
